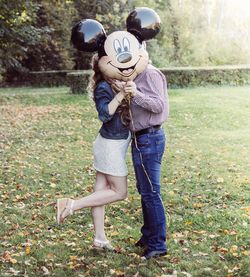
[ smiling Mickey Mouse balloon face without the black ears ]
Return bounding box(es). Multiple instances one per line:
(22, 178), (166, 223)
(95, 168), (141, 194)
(98, 31), (148, 81)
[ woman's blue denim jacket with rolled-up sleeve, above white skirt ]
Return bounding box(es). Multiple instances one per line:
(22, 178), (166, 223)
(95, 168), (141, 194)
(94, 81), (129, 139)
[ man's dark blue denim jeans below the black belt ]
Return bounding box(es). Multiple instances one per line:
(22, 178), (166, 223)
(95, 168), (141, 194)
(132, 129), (166, 251)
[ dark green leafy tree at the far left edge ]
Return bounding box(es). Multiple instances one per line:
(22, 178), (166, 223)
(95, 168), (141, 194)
(0, 0), (48, 80)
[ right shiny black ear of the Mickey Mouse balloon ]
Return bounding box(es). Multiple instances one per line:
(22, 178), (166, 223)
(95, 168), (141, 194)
(127, 7), (161, 42)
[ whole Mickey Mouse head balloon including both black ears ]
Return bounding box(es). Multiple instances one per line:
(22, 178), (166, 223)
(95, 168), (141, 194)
(71, 8), (160, 81)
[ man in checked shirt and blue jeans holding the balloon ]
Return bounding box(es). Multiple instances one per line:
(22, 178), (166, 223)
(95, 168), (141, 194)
(124, 64), (169, 259)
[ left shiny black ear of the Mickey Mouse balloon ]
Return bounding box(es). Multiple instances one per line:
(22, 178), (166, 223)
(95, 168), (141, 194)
(71, 19), (106, 52)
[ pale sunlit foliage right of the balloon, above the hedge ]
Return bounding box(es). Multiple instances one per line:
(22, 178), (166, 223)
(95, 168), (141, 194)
(134, 0), (250, 67)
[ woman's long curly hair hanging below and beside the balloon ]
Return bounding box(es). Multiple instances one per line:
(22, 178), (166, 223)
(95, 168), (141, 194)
(88, 54), (131, 127)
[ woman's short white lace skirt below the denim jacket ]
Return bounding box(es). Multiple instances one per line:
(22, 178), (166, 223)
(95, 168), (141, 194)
(93, 134), (131, 176)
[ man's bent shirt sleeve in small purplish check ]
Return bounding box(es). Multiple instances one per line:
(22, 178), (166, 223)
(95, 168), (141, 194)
(133, 71), (165, 113)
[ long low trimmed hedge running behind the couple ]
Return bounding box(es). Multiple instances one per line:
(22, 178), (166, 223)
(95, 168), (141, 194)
(1, 65), (250, 93)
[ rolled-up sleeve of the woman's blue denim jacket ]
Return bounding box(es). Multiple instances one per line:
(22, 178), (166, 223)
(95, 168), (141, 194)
(94, 83), (113, 123)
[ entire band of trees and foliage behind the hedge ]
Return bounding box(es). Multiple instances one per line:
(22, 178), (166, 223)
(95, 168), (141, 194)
(0, 0), (250, 81)
